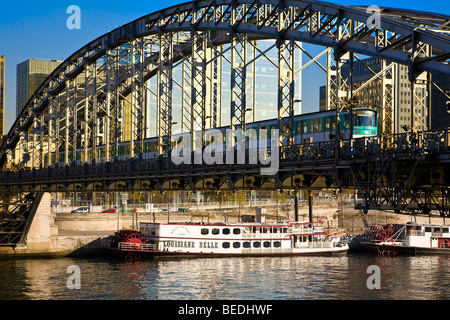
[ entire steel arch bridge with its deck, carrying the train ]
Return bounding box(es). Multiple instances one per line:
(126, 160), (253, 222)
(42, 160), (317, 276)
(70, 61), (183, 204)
(0, 0), (450, 245)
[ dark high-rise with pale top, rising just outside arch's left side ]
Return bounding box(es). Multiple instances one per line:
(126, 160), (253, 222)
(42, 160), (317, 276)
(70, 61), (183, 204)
(16, 59), (61, 116)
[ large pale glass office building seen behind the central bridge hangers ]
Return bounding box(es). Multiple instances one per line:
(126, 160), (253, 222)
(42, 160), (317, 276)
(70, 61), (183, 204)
(146, 40), (302, 137)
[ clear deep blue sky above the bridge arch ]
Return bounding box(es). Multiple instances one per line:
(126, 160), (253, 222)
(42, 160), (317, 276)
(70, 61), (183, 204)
(0, 0), (450, 132)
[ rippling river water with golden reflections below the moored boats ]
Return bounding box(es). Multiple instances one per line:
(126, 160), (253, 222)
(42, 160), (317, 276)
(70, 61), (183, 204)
(0, 254), (450, 300)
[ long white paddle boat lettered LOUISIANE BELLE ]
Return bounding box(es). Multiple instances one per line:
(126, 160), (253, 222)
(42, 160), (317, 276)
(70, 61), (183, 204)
(107, 221), (349, 256)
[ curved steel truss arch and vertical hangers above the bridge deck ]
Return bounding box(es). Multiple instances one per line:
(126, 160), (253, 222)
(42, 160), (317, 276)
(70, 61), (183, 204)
(0, 0), (450, 248)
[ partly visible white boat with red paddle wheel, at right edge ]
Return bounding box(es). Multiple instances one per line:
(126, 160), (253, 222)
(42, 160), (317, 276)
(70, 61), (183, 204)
(361, 222), (450, 255)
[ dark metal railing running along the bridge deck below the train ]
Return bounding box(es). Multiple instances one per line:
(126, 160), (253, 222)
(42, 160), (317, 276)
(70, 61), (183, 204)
(0, 129), (450, 185)
